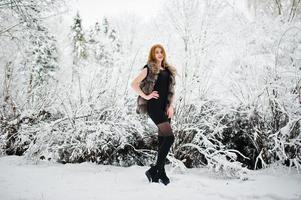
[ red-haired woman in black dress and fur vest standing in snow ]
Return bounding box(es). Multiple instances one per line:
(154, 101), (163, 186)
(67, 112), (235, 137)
(131, 44), (177, 185)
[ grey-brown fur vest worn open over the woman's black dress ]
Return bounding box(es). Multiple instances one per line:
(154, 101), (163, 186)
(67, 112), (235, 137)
(136, 62), (176, 114)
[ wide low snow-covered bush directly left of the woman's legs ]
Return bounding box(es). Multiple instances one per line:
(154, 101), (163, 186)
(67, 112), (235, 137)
(3, 100), (156, 166)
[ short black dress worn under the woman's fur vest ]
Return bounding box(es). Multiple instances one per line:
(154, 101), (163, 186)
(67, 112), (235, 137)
(144, 65), (171, 125)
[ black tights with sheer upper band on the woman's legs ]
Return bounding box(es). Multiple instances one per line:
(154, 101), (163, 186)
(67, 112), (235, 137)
(156, 121), (175, 170)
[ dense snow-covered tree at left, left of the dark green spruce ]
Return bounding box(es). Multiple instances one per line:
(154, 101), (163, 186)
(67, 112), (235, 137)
(23, 24), (59, 108)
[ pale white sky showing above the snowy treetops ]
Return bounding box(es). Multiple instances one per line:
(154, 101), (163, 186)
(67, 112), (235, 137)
(68, 0), (251, 27)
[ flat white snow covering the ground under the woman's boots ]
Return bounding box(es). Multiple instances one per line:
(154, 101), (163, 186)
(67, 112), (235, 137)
(0, 156), (301, 200)
